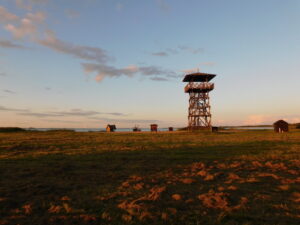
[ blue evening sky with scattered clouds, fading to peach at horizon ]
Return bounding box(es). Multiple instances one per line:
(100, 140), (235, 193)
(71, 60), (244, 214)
(0, 0), (300, 128)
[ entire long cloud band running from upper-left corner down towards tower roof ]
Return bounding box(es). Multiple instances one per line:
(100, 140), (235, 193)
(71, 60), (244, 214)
(2, 5), (176, 82)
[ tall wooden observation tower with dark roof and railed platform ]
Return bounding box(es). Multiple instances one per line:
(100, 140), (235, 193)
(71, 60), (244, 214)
(183, 72), (216, 130)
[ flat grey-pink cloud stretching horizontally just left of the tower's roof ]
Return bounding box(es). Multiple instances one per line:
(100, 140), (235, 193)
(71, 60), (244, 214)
(82, 63), (175, 82)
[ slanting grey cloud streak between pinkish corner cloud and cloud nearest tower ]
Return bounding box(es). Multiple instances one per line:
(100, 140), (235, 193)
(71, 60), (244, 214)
(37, 31), (111, 63)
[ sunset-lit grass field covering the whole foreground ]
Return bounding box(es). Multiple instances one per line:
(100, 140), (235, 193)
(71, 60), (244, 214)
(0, 131), (300, 225)
